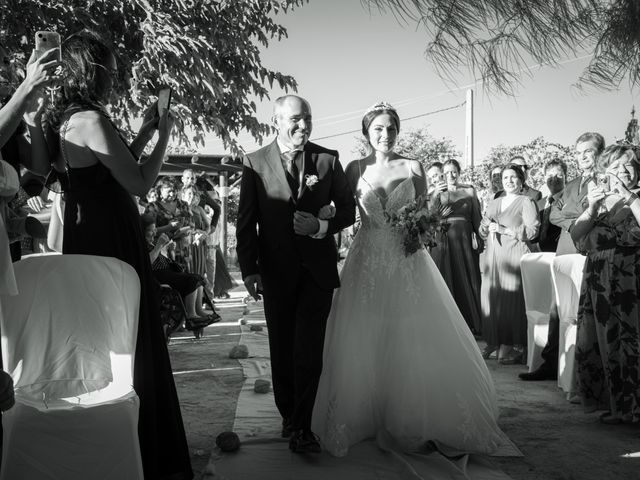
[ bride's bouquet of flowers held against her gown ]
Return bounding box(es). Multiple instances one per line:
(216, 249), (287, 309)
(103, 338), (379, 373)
(387, 195), (449, 257)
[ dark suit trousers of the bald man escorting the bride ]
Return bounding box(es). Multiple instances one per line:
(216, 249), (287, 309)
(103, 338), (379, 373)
(262, 266), (333, 430)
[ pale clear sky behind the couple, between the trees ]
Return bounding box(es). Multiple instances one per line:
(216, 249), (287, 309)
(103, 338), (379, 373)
(203, 0), (640, 164)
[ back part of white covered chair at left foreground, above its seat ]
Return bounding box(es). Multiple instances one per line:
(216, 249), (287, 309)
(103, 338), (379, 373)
(0, 254), (140, 410)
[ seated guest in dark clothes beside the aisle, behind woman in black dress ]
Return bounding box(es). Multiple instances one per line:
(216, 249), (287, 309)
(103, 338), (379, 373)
(140, 214), (220, 336)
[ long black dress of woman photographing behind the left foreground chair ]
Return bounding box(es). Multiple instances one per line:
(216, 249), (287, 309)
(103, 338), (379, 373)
(62, 163), (193, 480)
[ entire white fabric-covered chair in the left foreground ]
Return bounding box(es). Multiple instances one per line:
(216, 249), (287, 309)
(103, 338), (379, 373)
(0, 254), (143, 480)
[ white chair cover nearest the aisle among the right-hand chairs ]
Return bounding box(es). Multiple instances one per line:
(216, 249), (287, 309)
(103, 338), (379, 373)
(520, 252), (556, 372)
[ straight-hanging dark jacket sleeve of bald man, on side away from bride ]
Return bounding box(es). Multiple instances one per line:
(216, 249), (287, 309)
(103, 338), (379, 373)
(236, 157), (259, 278)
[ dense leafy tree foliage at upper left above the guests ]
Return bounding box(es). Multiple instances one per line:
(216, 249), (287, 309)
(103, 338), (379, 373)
(0, 0), (308, 153)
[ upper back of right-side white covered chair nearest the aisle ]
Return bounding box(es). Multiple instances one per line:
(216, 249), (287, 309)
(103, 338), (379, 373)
(520, 252), (555, 314)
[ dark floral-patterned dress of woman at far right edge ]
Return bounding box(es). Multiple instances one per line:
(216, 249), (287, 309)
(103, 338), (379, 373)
(576, 195), (640, 422)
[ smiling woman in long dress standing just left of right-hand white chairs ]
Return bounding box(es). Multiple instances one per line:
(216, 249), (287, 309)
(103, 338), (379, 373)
(480, 164), (540, 364)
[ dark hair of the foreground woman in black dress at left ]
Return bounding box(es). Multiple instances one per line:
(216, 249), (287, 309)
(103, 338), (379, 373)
(46, 30), (113, 132)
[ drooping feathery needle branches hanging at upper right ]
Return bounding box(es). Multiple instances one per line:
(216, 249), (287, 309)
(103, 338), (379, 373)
(361, 0), (640, 94)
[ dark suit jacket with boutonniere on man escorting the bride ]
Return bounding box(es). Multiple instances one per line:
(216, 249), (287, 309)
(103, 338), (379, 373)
(236, 141), (355, 289)
